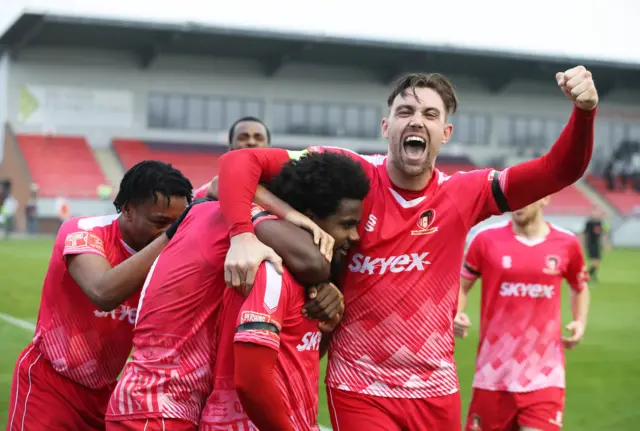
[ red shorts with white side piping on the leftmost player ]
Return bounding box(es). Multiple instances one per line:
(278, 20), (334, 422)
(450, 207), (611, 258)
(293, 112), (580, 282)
(7, 344), (113, 431)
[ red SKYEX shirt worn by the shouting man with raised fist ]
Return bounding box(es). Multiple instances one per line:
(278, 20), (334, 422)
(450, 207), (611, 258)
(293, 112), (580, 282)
(298, 148), (508, 398)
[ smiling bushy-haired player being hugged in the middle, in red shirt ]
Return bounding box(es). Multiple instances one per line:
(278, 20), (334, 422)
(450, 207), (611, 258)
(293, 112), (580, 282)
(199, 153), (369, 431)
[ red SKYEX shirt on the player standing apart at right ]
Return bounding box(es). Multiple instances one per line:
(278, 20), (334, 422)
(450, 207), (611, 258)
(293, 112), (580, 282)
(461, 221), (588, 392)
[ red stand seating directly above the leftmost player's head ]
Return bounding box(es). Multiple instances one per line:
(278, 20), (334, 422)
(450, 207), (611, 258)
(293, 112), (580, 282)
(113, 139), (227, 187)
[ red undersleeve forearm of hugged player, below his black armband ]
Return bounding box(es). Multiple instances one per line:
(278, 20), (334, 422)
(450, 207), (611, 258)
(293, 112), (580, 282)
(234, 343), (293, 431)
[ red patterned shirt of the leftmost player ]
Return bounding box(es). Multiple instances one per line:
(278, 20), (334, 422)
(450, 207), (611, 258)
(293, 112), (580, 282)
(33, 214), (139, 388)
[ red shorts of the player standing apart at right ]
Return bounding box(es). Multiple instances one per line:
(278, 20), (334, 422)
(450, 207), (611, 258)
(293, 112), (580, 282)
(466, 388), (564, 431)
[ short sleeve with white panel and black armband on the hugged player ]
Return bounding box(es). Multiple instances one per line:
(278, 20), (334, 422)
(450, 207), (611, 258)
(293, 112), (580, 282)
(234, 262), (289, 350)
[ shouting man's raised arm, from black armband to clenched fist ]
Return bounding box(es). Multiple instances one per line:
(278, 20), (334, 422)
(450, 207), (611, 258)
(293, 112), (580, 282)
(493, 66), (598, 212)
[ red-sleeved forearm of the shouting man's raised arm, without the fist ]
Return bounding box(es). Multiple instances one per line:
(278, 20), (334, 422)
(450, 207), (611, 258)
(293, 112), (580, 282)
(503, 108), (596, 211)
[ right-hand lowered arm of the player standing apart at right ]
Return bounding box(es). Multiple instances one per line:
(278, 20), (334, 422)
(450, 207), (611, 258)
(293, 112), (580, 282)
(562, 240), (590, 349)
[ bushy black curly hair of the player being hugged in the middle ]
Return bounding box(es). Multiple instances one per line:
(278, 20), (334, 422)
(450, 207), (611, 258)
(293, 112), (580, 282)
(267, 151), (369, 219)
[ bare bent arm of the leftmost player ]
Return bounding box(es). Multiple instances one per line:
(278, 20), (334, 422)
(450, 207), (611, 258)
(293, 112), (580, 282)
(65, 232), (169, 311)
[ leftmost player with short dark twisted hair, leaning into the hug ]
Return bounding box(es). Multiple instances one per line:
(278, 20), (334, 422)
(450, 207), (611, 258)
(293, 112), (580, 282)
(7, 161), (193, 431)
